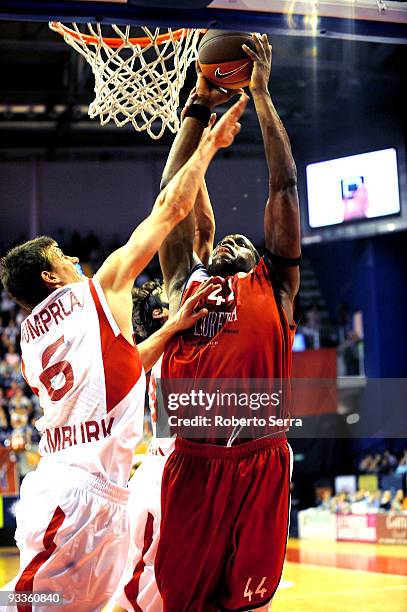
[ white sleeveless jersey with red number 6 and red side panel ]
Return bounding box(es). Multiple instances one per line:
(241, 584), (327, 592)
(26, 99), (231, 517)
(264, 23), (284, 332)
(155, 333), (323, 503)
(21, 278), (145, 486)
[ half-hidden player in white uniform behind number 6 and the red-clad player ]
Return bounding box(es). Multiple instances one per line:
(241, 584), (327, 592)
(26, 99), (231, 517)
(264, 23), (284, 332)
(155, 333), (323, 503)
(115, 159), (215, 612)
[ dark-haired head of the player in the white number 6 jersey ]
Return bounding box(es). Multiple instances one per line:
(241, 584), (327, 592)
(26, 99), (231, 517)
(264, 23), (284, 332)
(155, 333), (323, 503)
(1, 236), (83, 311)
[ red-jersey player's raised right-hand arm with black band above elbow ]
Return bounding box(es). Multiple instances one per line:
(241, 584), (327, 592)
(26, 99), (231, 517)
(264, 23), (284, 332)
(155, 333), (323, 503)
(243, 34), (301, 306)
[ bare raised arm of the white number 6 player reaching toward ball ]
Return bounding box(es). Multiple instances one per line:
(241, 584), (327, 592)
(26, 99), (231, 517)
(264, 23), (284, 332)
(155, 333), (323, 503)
(96, 96), (247, 340)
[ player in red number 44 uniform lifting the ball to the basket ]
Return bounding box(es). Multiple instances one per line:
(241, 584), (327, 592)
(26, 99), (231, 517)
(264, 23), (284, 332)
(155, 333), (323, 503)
(155, 34), (300, 612)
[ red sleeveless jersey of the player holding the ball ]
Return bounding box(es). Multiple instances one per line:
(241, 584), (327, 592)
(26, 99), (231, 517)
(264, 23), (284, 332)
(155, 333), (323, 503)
(161, 258), (295, 444)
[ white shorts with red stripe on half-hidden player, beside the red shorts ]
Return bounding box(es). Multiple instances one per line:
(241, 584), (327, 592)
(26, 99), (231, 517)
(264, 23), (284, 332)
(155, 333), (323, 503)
(115, 454), (168, 612)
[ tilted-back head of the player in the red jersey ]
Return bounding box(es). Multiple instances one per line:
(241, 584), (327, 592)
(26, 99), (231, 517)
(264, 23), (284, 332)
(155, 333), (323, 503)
(208, 234), (260, 276)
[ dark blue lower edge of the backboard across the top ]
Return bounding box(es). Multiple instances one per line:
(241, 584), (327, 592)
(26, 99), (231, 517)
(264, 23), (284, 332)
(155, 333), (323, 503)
(0, 0), (407, 44)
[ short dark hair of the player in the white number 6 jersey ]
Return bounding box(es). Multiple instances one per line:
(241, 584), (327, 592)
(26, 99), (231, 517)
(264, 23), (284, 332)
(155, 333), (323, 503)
(0, 236), (56, 309)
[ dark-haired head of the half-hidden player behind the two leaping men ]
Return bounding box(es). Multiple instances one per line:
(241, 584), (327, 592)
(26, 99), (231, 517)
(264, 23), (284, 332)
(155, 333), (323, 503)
(132, 279), (168, 341)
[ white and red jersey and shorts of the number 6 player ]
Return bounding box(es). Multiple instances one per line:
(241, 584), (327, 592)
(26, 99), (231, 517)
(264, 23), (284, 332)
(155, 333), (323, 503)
(4, 278), (145, 612)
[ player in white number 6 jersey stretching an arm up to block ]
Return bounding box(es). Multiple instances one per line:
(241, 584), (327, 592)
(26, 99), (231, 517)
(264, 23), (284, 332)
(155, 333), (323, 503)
(1, 96), (247, 612)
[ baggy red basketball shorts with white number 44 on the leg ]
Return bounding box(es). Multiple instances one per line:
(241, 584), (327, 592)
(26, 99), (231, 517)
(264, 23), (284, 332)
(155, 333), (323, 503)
(155, 438), (291, 612)
